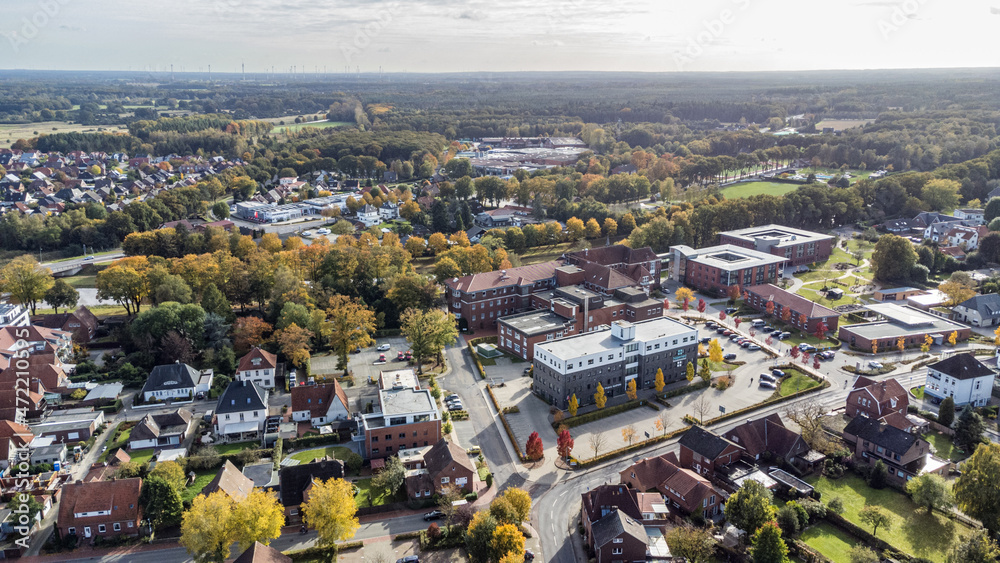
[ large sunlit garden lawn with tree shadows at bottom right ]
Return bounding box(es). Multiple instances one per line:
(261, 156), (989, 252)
(807, 474), (972, 561)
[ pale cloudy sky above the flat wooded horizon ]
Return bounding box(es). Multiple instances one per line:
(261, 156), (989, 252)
(0, 0), (1000, 73)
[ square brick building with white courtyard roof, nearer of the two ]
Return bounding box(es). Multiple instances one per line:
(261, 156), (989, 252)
(670, 244), (788, 295)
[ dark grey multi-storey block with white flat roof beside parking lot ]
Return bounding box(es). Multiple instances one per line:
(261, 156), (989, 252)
(533, 317), (698, 409)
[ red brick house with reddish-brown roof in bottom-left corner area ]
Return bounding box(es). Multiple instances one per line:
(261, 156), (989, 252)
(56, 477), (142, 543)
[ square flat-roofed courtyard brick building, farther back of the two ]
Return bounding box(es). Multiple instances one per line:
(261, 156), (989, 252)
(719, 225), (834, 266)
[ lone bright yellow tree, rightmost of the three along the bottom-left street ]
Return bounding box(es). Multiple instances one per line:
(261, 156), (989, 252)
(302, 479), (361, 546)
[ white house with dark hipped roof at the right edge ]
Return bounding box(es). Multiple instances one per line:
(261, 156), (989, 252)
(924, 353), (996, 407)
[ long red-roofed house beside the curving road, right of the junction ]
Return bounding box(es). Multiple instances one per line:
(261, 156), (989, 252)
(618, 452), (723, 517)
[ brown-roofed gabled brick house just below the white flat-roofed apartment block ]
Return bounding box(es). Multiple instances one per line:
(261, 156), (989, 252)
(401, 438), (479, 499)
